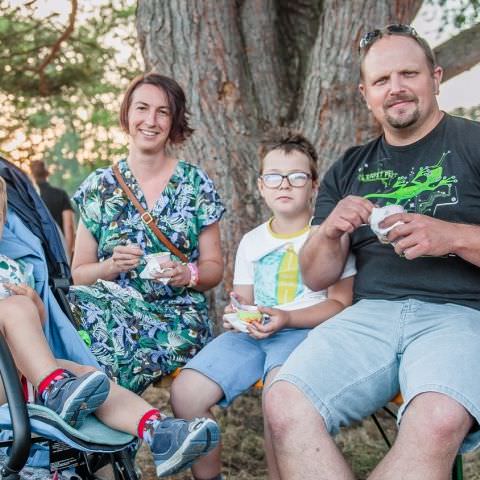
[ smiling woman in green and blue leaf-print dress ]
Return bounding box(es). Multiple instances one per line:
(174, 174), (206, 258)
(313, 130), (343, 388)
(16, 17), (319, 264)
(69, 73), (225, 393)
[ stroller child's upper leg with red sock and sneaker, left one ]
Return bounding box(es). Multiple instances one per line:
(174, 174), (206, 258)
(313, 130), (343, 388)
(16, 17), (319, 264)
(0, 295), (109, 428)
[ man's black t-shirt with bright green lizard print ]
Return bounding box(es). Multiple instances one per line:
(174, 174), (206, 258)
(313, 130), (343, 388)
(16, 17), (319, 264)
(313, 115), (480, 309)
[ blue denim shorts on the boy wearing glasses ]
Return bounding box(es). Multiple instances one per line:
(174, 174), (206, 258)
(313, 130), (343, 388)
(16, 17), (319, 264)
(183, 329), (310, 407)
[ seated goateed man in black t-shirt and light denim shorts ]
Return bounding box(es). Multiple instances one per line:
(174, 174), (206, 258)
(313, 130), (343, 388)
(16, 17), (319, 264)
(265, 25), (480, 480)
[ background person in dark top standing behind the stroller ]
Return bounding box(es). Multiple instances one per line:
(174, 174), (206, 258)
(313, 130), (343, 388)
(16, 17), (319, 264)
(30, 160), (75, 259)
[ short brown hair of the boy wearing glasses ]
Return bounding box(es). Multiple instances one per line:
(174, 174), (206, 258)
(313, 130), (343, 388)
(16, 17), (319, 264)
(258, 127), (318, 182)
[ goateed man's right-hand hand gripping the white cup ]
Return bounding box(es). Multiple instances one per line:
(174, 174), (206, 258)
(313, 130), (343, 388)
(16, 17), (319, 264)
(380, 213), (457, 260)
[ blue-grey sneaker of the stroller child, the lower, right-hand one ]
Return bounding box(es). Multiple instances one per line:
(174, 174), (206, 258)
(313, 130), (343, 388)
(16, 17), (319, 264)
(150, 418), (220, 477)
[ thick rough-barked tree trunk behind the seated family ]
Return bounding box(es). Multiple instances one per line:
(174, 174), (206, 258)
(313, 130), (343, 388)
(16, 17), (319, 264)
(137, 0), (422, 318)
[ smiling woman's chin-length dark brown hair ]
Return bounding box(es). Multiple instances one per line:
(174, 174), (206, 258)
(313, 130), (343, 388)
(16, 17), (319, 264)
(120, 73), (193, 143)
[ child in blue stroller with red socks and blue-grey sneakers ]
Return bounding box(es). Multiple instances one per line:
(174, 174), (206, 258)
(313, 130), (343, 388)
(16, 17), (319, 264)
(0, 177), (219, 476)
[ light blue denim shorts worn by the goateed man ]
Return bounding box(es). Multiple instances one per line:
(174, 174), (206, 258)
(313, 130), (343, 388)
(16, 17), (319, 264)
(274, 300), (480, 452)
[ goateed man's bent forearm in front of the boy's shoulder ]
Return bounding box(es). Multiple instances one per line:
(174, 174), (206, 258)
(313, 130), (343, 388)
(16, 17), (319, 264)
(300, 225), (350, 291)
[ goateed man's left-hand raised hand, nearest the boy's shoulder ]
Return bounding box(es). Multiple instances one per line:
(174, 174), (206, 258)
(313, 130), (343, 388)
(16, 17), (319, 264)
(322, 195), (374, 240)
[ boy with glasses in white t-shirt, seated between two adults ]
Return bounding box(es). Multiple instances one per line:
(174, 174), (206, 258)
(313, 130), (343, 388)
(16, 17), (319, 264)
(171, 132), (355, 480)
